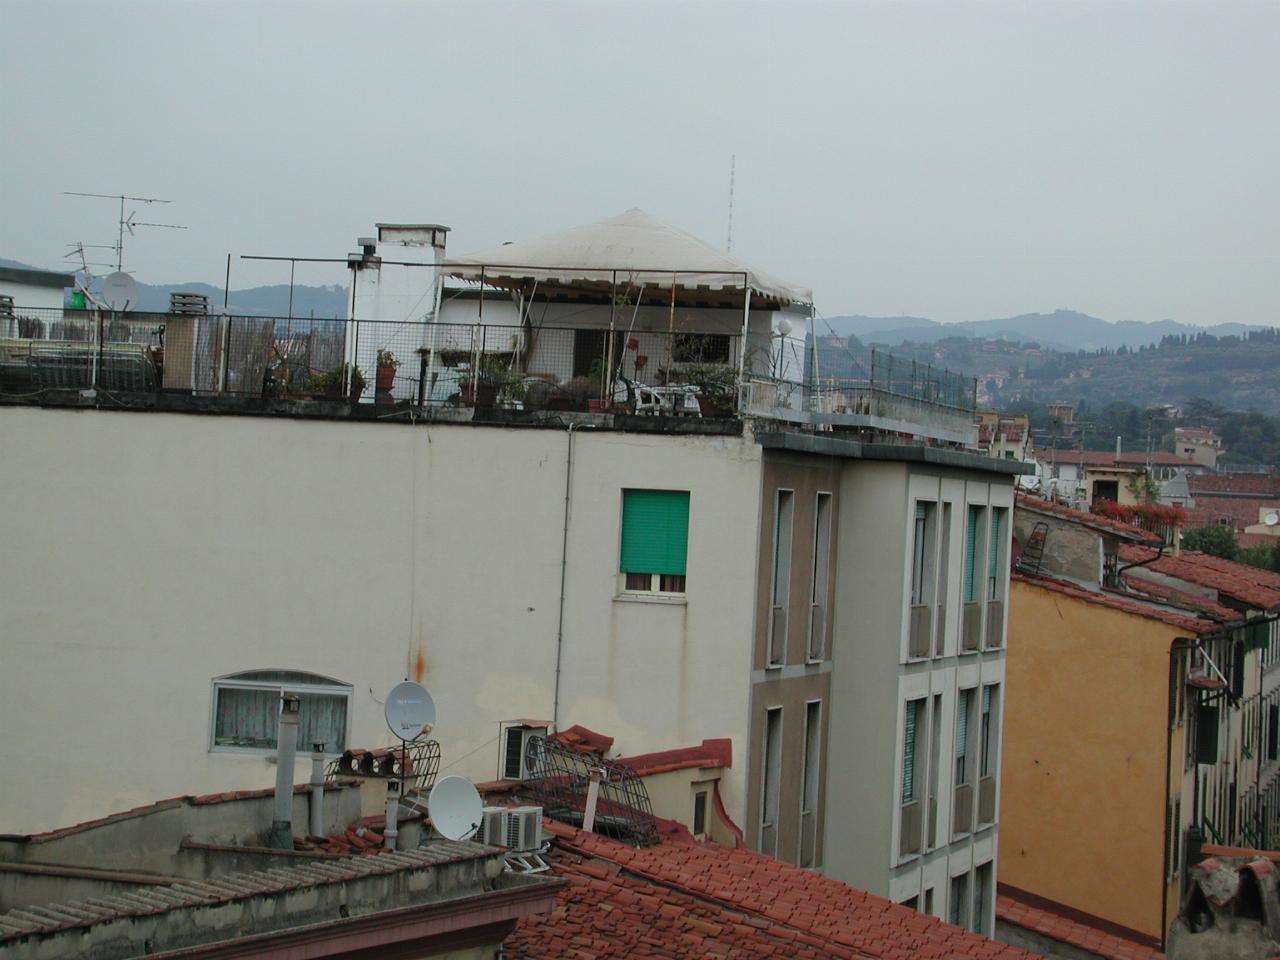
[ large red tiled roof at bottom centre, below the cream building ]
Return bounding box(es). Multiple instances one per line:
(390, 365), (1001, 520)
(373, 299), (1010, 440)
(504, 823), (1034, 960)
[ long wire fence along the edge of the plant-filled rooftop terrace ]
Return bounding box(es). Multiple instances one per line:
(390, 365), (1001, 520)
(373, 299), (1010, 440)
(0, 307), (977, 416)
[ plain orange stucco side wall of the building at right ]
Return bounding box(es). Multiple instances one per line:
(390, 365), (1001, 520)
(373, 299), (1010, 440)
(998, 581), (1180, 937)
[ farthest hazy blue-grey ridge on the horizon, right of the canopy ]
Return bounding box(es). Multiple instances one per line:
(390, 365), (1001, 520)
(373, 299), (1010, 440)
(819, 310), (1266, 351)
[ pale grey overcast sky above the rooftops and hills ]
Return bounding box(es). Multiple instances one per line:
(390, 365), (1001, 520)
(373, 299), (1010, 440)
(0, 0), (1280, 324)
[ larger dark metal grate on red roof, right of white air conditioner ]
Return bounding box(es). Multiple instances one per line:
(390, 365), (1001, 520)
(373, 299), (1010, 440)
(525, 737), (658, 846)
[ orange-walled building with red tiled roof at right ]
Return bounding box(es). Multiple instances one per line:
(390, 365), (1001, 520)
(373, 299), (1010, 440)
(1000, 498), (1280, 948)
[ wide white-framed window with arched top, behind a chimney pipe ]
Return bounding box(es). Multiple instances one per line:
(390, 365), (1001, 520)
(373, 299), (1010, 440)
(210, 669), (351, 754)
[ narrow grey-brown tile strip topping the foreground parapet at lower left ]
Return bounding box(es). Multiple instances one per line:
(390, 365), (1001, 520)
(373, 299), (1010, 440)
(0, 840), (494, 945)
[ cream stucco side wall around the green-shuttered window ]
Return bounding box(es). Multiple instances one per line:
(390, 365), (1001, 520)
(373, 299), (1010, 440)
(0, 408), (760, 832)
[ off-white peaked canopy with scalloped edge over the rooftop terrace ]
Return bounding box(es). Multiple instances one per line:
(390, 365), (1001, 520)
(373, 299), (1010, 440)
(443, 209), (813, 314)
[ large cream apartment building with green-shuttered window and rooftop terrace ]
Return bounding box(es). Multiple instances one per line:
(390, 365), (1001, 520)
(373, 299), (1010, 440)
(0, 209), (1023, 936)
